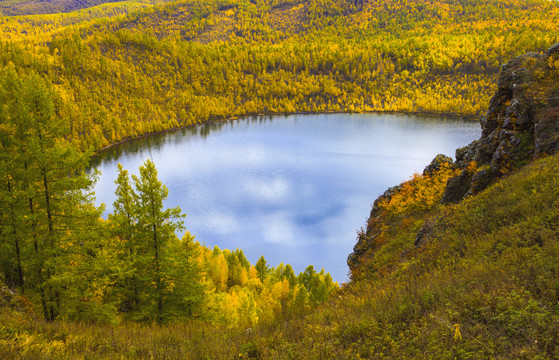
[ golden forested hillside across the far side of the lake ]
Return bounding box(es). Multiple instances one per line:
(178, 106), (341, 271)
(0, 0), (559, 149)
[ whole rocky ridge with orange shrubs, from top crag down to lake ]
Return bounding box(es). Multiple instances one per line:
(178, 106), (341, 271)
(348, 43), (559, 272)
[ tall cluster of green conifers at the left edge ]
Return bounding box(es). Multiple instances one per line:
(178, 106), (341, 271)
(0, 66), (101, 321)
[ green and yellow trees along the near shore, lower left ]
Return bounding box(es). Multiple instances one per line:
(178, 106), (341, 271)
(0, 70), (338, 326)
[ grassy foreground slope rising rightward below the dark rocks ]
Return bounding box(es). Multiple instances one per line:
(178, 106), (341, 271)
(0, 156), (559, 359)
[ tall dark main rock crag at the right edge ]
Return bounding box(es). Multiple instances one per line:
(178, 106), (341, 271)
(443, 43), (559, 203)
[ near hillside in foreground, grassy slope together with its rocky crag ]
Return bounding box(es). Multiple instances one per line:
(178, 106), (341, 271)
(0, 43), (559, 359)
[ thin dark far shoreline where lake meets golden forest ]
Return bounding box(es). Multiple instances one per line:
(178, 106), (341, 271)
(92, 111), (479, 157)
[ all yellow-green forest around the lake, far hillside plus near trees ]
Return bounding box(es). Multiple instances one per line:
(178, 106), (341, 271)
(0, 0), (559, 323)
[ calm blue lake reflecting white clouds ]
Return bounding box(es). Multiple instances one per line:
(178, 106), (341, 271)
(94, 114), (481, 282)
